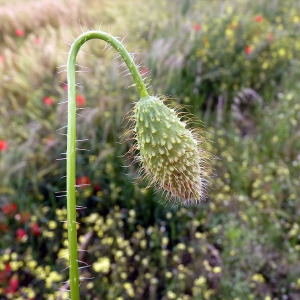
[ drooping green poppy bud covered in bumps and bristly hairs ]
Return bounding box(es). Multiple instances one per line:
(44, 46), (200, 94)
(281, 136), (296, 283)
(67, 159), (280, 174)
(135, 96), (211, 204)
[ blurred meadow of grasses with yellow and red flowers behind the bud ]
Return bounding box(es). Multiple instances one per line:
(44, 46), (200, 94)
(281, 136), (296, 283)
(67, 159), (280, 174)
(0, 0), (300, 300)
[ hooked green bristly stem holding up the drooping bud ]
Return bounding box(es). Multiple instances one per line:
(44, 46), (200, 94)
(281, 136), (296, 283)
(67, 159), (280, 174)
(67, 31), (149, 300)
